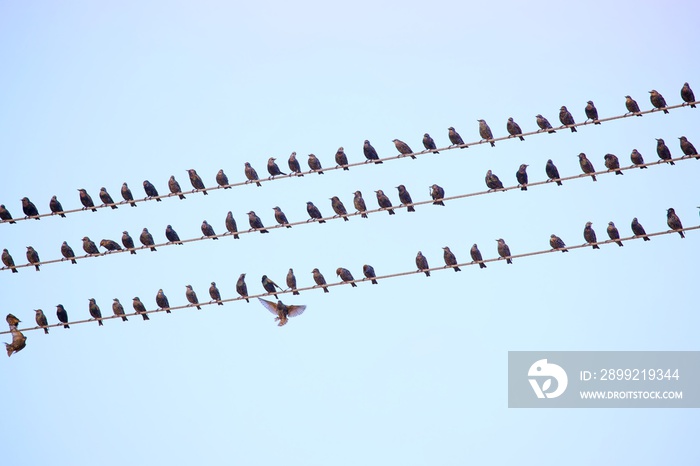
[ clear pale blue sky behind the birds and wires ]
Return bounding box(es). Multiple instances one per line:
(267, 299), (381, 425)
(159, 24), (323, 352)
(0, 0), (700, 466)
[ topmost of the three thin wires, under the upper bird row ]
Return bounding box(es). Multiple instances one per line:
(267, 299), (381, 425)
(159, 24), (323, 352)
(0, 101), (700, 223)
